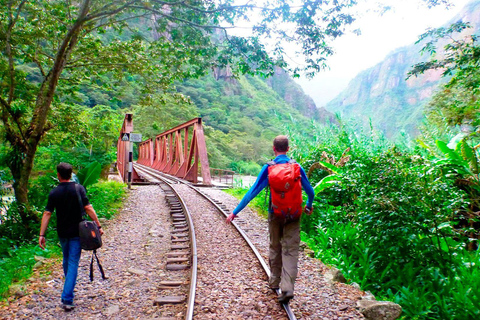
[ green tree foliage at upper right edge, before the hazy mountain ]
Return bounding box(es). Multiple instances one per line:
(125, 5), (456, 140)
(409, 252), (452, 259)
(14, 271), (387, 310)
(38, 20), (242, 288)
(409, 22), (480, 128)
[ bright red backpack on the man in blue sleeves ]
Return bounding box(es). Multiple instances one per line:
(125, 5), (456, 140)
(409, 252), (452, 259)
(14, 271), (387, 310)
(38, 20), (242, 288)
(268, 160), (303, 220)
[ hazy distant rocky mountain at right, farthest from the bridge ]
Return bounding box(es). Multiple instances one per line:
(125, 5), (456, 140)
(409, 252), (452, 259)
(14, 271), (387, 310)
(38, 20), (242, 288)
(326, 0), (480, 137)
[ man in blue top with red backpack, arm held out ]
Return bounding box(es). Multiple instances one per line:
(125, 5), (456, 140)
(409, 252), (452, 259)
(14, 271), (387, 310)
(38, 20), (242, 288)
(227, 136), (315, 303)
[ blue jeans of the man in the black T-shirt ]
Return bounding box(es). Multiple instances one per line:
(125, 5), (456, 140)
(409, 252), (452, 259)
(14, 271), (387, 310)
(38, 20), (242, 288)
(60, 237), (82, 304)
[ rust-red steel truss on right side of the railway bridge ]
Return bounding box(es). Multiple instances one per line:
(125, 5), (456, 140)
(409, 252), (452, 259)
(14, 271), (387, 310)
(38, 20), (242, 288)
(137, 118), (212, 185)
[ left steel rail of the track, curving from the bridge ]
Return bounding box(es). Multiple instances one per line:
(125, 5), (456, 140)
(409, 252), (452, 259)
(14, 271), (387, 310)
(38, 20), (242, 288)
(135, 164), (198, 320)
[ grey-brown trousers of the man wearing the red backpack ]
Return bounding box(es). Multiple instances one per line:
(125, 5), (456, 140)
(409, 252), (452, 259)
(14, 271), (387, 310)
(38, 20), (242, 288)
(268, 213), (300, 293)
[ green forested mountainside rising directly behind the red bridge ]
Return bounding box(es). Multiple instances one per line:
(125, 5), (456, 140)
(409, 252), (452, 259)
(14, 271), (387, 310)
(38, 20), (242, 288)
(133, 69), (333, 173)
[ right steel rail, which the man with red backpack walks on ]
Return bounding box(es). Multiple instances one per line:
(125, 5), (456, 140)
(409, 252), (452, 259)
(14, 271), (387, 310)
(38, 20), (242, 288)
(135, 164), (297, 320)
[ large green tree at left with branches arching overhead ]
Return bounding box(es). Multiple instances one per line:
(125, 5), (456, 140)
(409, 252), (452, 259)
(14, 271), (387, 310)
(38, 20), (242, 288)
(0, 0), (354, 222)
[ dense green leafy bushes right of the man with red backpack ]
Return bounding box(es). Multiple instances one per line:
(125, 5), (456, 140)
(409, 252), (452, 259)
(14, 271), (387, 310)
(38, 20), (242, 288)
(284, 120), (480, 319)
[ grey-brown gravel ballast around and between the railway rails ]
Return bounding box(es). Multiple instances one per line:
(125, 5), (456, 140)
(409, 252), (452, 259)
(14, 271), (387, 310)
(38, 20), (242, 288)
(0, 185), (363, 320)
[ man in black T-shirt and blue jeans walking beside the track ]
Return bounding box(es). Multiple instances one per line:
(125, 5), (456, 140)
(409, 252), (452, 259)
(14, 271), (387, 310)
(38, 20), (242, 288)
(38, 162), (103, 311)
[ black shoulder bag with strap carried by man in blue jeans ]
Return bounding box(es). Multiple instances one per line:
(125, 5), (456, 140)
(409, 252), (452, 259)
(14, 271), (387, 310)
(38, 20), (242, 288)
(75, 184), (106, 281)
